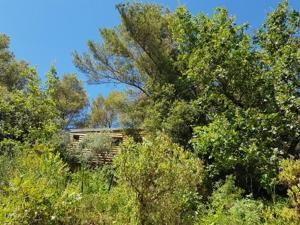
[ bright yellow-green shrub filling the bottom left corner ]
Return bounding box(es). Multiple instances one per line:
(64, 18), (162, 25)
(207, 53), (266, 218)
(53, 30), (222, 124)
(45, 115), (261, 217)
(0, 145), (80, 225)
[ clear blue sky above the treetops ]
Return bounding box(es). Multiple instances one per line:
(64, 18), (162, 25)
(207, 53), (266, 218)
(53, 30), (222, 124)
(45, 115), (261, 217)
(0, 0), (300, 98)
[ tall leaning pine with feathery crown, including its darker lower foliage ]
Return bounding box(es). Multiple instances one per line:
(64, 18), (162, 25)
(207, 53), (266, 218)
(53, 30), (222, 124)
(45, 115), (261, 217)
(74, 3), (204, 145)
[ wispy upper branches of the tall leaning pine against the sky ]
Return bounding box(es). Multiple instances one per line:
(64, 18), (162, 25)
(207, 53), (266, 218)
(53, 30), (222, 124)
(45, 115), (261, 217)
(74, 3), (172, 95)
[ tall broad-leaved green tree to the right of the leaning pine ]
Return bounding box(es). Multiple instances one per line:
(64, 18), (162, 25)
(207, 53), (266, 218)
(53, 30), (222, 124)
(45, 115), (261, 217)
(172, 1), (300, 195)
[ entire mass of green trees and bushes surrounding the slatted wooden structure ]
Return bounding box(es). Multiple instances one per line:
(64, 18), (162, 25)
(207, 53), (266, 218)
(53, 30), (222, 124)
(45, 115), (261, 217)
(0, 1), (300, 225)
